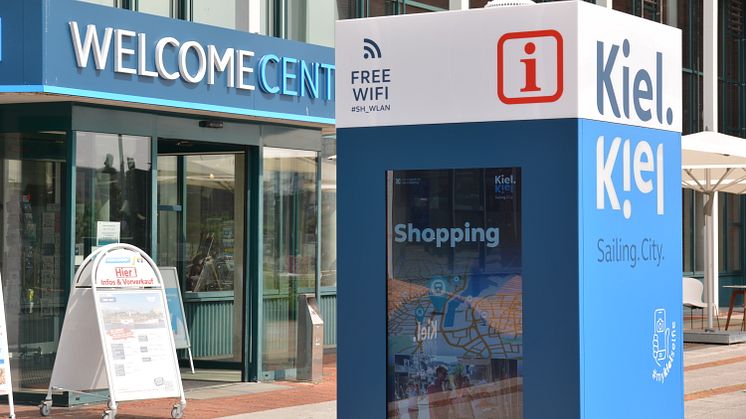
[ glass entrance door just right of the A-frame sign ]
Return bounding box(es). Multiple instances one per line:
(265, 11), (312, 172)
(158, 149), (246, 366)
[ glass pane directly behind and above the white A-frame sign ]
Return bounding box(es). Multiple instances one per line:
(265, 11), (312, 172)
(75, 132), (151, 265)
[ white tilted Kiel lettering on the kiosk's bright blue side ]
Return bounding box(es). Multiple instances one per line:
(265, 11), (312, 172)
(596, 135), (664, 219)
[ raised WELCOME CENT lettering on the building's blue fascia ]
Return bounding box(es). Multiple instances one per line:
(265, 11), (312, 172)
(69, 21), (335, 100)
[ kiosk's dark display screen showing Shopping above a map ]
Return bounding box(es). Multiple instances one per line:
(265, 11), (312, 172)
(386, 168), (523, 419)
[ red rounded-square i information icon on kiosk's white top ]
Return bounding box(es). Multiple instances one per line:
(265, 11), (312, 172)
(497, 29), (563, 105)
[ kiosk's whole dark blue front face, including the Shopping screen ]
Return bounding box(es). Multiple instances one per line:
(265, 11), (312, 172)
(337, 119), (581, 419)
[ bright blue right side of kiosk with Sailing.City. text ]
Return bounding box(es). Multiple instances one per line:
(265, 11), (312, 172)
(579, 120), (684, 419)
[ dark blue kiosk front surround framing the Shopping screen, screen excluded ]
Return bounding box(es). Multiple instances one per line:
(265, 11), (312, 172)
(337, 119), (580, 419)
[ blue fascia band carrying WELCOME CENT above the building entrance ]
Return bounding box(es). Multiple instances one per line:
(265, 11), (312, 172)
(0, 0), (335, 124)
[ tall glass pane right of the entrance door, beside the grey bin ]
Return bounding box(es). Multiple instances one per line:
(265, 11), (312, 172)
(262, 147), (318, 371)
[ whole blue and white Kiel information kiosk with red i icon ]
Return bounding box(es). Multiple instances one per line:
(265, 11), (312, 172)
(336, 2), (684, 419)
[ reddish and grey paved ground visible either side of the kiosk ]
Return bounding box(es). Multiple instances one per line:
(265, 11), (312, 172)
(0, 344), (746, 419)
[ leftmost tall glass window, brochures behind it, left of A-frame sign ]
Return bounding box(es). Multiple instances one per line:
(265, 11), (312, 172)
(0, 132), (68, 390)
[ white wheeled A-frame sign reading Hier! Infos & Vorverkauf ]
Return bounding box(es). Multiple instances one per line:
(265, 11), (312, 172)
(39, 243), (186, 419)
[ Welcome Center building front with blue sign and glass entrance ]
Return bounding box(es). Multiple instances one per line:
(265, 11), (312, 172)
(0, 0), (336, 400)
